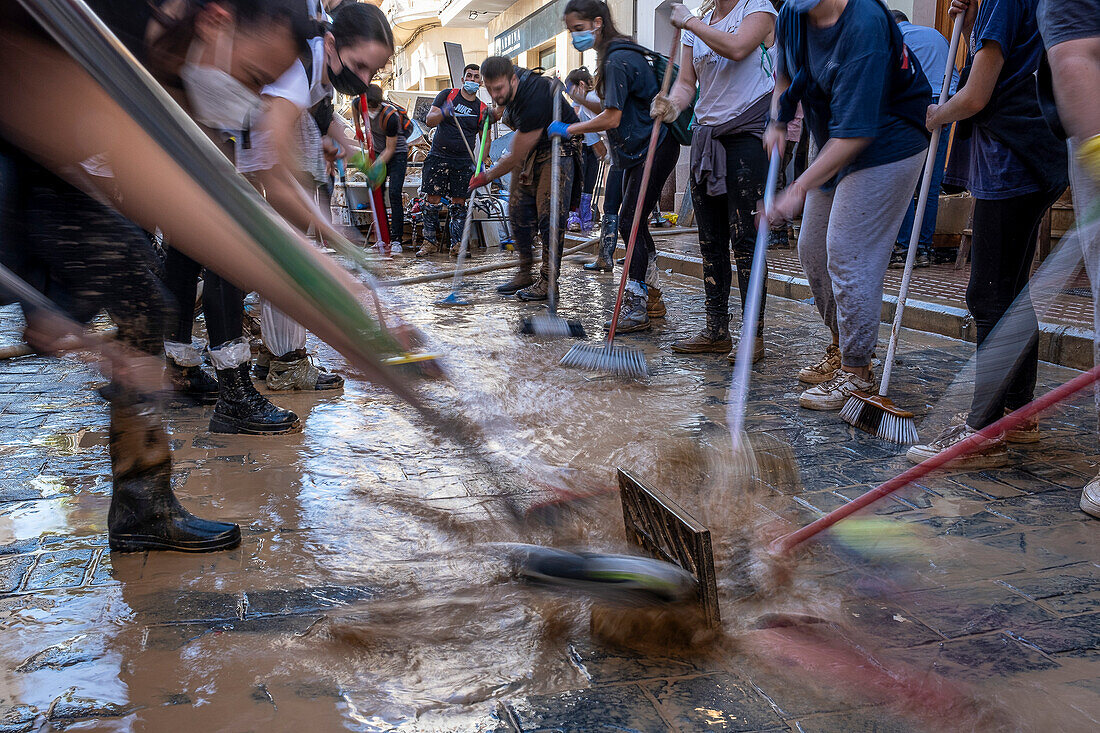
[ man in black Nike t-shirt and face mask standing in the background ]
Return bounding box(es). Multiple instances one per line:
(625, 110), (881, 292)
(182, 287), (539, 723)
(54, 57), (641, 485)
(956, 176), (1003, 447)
(416, 64), (488, 258)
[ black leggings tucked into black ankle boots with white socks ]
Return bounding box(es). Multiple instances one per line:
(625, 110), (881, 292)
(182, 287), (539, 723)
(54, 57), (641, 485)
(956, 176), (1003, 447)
(164, 247), (244, 347)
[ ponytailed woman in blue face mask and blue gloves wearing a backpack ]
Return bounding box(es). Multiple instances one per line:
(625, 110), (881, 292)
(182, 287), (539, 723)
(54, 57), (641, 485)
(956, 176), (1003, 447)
(550, 0), (680, 333)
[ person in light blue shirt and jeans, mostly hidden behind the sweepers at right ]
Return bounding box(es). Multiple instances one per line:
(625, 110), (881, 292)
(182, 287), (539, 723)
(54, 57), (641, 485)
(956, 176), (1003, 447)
(890, 10), (959, 270)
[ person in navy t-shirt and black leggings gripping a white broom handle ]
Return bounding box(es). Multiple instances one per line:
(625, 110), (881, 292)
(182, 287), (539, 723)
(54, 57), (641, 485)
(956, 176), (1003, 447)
(908, 0), (1068, 468)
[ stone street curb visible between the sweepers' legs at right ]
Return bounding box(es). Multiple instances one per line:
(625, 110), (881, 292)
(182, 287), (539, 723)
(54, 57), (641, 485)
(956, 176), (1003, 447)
(615, 248), (1092, 370)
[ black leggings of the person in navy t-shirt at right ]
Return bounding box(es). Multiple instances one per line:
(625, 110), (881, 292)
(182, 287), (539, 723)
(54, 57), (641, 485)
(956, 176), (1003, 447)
(966, 189), (1062, 429)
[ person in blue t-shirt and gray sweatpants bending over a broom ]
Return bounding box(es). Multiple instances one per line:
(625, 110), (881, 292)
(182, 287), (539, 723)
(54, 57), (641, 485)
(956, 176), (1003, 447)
(765, 0), (932, 409)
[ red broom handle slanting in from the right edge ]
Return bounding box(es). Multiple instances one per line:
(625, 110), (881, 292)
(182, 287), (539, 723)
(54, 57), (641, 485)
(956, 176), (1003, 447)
(771, 364), (1100, 554)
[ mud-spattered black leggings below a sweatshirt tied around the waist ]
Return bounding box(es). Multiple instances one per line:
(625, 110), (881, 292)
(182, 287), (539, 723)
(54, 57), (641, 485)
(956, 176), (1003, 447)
(691, 134), (768, 336)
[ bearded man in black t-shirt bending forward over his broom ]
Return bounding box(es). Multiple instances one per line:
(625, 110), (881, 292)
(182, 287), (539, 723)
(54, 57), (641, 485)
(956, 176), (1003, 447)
(470, 56), (580, 300)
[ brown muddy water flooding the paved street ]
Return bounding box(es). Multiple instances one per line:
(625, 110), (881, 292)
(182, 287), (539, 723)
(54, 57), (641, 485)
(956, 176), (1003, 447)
(0, 254), (1100, 731)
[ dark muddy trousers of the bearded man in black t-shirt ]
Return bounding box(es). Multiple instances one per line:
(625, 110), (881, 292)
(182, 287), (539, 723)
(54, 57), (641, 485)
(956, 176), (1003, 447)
(508, 147), (575, 273)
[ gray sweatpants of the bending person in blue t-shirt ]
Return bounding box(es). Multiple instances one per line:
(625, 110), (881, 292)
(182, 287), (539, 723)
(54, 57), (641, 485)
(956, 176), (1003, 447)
(799, 151), (924, 367)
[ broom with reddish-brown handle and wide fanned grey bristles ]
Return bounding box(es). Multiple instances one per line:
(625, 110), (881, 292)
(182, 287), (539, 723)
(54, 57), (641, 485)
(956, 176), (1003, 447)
(561, 29), (680, 379)
